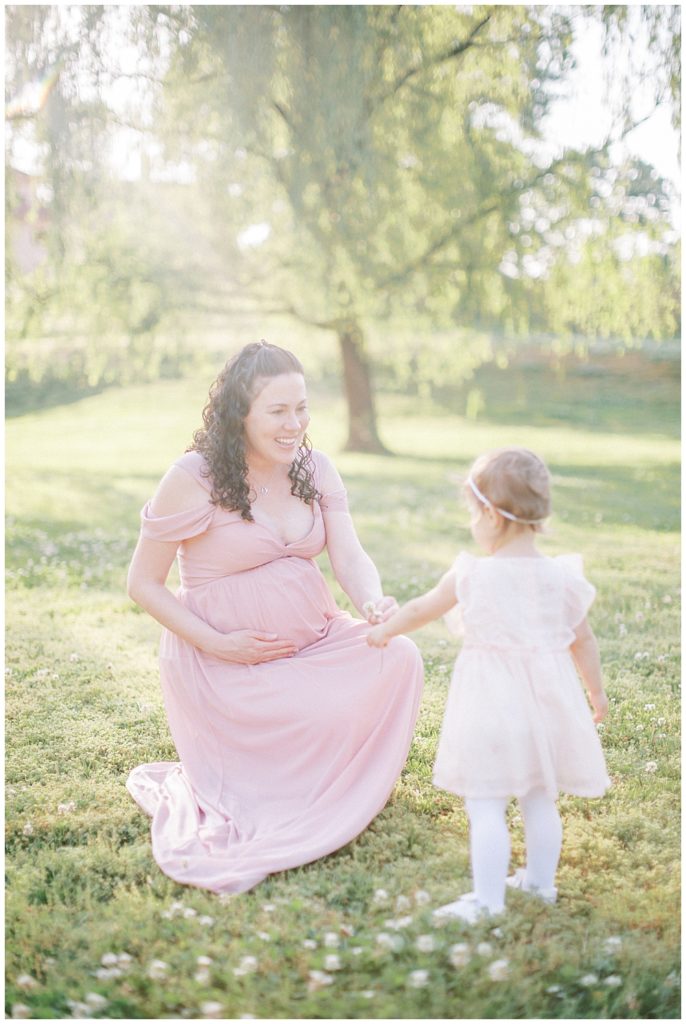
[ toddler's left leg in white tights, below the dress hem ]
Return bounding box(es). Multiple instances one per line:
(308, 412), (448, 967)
(465, 799), (510, 913)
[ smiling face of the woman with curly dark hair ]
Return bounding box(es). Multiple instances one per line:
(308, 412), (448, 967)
(243, 373), (309, 466)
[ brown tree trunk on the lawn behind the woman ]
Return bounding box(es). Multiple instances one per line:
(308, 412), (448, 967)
(336, 321), (390, 455)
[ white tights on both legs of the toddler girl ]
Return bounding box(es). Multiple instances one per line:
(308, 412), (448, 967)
(465, 790), (562, 913)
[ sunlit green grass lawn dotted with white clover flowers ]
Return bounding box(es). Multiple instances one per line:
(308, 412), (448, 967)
(6, 352), (680, 1019)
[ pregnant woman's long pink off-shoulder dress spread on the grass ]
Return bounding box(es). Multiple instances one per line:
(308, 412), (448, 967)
(127, 452), (423, 893)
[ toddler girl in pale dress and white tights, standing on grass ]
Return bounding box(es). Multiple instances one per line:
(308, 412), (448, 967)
(368, 447), (609, 923)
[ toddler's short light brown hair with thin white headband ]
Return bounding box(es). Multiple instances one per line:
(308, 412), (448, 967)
(465, 447), (552, 532)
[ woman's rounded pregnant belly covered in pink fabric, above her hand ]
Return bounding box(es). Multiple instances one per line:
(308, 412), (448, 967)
(173, 558), (341, 649)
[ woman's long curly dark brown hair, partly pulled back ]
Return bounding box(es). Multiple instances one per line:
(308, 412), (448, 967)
(186, 341), (321, 522)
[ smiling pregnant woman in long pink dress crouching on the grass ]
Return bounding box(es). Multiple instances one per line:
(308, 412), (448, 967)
(127, 342), (422, 892)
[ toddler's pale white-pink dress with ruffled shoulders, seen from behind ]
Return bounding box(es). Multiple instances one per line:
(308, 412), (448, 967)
(433, 552), (610, 799)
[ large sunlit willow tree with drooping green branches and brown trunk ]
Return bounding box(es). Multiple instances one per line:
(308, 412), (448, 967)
(6, 5), (680, 451)
